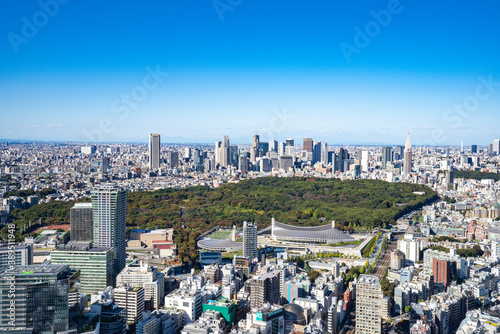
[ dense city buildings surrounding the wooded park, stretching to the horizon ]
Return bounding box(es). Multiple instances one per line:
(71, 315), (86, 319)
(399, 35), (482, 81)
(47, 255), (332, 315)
(0, 133), (500, 334)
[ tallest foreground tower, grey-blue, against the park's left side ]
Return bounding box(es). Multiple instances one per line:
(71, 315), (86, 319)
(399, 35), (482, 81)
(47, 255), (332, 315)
(91, 184), (127, 277)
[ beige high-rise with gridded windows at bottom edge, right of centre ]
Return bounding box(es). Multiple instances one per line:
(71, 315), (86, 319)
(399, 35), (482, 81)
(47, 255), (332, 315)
(356, 275), (384, 334)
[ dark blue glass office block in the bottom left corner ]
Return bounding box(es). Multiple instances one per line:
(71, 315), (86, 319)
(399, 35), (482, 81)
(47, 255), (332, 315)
(0, 264), (76, 333)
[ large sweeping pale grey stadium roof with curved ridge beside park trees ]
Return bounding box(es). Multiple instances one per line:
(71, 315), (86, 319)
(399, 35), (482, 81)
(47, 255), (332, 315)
(271, 221), (356, 243)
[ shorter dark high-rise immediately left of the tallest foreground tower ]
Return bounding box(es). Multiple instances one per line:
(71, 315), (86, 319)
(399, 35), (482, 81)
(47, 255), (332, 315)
(70, 203), (94, 242)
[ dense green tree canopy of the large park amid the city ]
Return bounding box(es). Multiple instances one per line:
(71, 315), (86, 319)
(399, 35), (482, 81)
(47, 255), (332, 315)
(6, 177), (438, 261)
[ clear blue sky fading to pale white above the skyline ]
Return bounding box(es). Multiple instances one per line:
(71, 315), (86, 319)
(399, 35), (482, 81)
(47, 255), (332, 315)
(0, 0), (500, 145)
